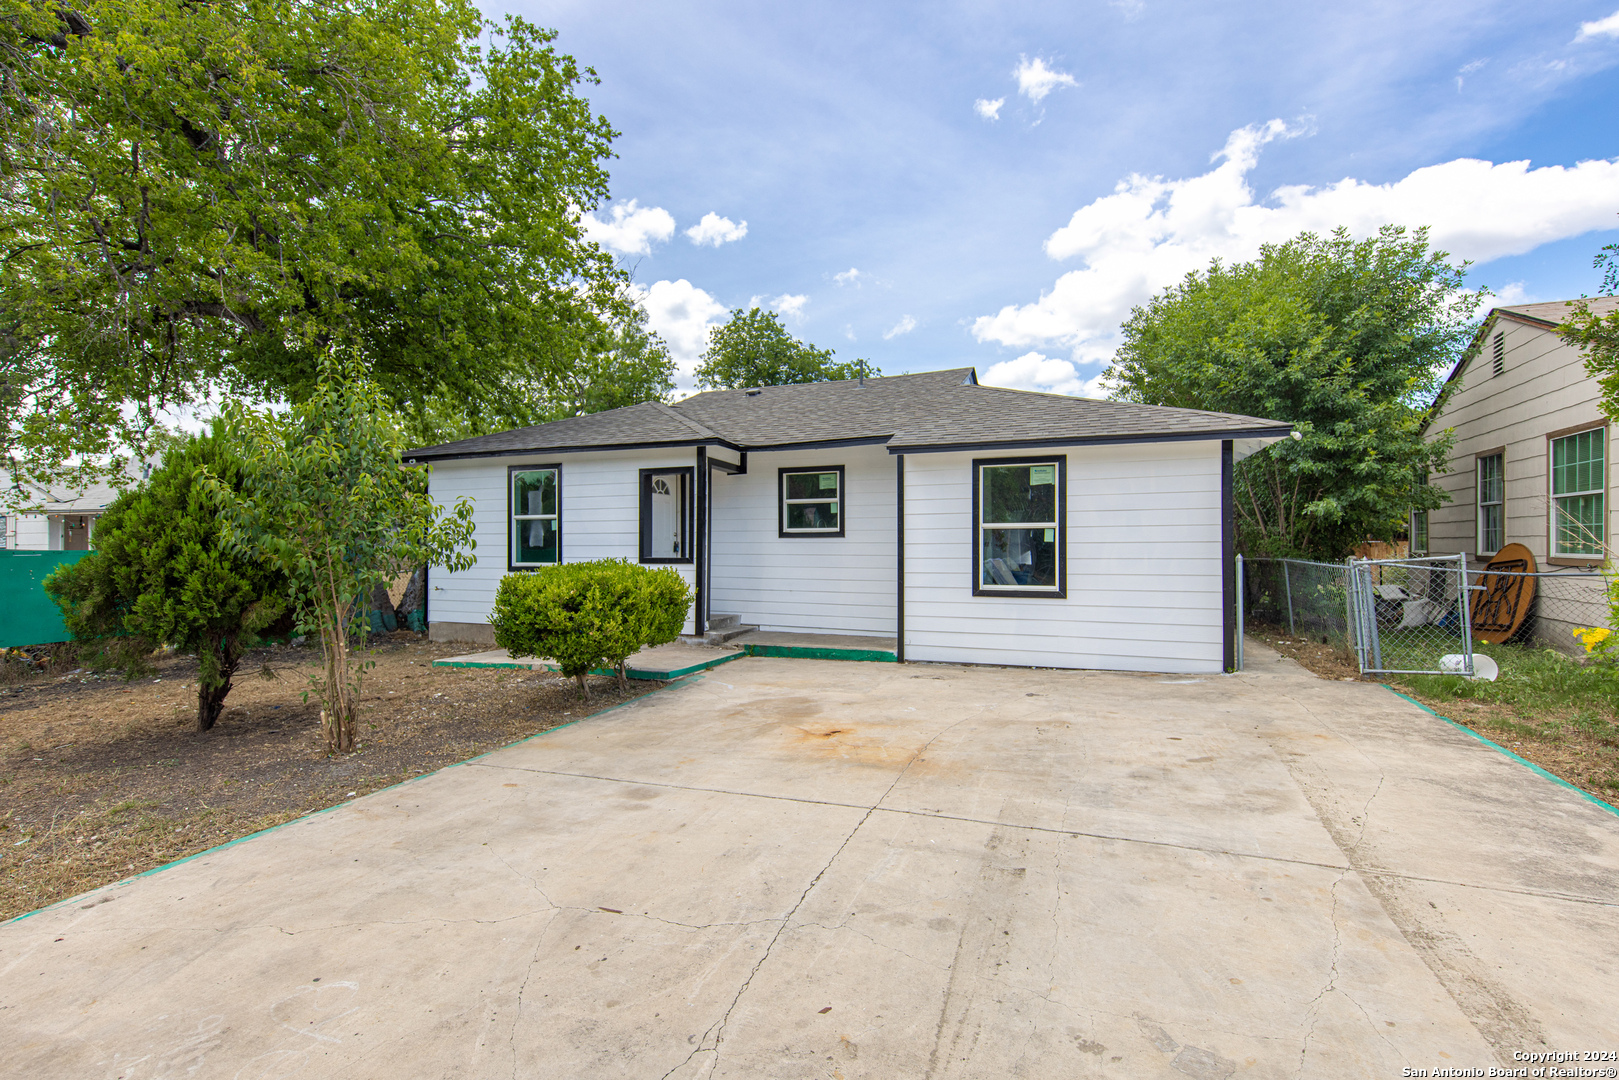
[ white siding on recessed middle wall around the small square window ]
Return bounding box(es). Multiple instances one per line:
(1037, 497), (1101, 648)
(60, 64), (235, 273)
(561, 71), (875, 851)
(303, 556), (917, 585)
(709, 447), (899, 636)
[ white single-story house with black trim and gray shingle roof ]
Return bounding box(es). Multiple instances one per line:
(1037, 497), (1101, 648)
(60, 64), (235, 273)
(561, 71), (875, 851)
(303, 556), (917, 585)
(405, 368), (1290, 672)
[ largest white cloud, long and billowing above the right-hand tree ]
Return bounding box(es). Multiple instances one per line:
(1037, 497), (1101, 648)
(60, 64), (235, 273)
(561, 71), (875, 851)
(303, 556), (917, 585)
(973, 120), (1619, 359)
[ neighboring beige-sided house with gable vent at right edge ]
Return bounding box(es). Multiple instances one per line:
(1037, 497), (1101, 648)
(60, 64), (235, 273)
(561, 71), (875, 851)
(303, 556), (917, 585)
(1410, 296), (1619, 646)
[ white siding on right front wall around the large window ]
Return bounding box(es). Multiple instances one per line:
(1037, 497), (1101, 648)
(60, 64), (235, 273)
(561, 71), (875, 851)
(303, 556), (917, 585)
(905, 440), (1224, 672)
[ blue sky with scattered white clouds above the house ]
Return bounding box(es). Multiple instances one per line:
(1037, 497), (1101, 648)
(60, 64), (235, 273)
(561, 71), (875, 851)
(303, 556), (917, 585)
(511, 0), (1619, 393)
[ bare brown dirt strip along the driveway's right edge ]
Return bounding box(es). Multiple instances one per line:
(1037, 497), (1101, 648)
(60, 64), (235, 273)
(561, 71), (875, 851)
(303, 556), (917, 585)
(1248, 628), (1619, 803)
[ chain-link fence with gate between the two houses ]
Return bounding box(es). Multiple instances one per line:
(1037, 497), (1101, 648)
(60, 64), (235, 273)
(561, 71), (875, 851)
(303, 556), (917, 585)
(1243, 555), (1609, 672)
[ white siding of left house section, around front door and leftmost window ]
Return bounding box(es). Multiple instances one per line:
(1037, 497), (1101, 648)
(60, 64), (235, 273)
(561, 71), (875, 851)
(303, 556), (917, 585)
(427, 449), (696, 633)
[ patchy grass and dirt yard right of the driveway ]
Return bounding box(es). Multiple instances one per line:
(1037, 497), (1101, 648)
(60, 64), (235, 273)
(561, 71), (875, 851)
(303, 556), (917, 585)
(1248, 628), (1619, 803)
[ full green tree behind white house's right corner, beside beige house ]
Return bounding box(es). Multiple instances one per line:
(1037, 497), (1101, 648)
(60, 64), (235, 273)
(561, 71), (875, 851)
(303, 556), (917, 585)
(1107, 227), (1481, 559)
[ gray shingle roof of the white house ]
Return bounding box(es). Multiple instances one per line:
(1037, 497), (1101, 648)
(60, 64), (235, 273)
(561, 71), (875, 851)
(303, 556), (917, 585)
(405, 368), (1289, 460)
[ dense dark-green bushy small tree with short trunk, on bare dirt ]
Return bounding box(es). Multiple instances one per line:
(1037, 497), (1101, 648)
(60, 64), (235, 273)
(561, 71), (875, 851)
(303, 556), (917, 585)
(45, 434), (287, 732)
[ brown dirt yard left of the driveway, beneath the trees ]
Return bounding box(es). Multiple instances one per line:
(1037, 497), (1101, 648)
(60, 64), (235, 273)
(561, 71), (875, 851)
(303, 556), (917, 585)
(0, 633), (664, 920)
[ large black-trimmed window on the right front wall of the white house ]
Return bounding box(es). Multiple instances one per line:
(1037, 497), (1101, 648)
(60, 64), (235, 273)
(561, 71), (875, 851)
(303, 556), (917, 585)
(973, 455), (1069, 599)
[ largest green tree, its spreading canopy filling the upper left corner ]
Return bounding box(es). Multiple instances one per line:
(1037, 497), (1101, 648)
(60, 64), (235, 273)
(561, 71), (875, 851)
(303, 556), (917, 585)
(0, 0), (628, 505)
